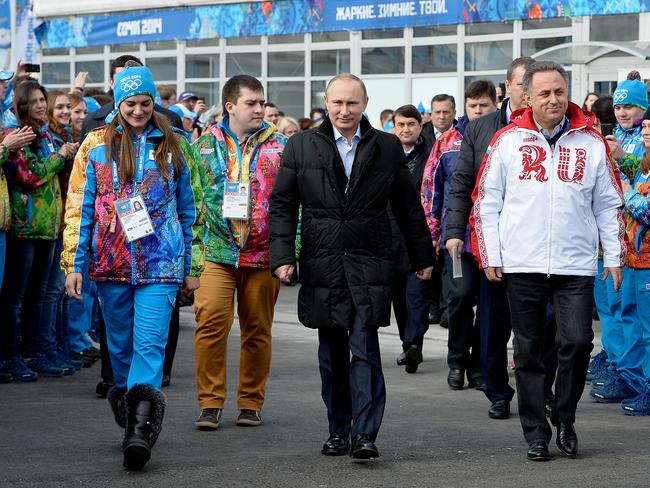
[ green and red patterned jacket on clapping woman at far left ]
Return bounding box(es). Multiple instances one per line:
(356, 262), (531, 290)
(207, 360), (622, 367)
(4, 124), (64, 240)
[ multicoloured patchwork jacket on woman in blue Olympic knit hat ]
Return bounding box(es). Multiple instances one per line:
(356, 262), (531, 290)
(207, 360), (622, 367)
(61, 127), (204, 285)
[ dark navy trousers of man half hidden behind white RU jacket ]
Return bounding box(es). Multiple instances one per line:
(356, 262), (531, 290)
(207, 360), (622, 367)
(479, 273), (515, 403)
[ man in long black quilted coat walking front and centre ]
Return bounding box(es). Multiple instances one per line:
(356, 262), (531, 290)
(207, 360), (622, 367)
(269, 74), (434, 459)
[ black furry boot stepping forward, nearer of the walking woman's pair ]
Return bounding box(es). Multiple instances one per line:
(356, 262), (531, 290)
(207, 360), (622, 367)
(122, 385), (166, 470)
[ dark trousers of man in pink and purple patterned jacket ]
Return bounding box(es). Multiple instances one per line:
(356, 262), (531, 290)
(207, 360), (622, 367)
(444, 251), (481, 377)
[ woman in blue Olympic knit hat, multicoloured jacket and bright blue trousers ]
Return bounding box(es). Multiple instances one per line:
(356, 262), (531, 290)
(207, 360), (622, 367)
(61, 66), (204, 469)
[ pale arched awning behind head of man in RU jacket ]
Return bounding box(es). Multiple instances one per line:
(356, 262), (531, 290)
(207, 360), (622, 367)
(533, 41), (650, 65)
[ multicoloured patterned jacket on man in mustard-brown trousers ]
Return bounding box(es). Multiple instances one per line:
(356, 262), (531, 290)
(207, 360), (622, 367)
(194, 117), (287, 268)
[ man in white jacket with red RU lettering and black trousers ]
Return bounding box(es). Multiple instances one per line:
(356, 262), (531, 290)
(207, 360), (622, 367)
(471, 62), (626, 461)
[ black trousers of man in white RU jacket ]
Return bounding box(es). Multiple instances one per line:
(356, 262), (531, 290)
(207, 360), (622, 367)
(504, 273), (594, 443)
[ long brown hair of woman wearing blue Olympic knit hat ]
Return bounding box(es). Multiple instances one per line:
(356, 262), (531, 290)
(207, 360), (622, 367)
(104, 112), (185, 182)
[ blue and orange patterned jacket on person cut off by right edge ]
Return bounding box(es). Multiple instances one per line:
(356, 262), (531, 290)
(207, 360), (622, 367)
(625, 171), (650, 269)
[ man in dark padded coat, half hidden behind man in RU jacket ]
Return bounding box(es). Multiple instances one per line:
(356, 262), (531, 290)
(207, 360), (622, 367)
(446, 58), (535, 419)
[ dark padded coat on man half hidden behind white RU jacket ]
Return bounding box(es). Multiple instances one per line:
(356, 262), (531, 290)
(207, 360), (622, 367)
(445, 98), (510, 241)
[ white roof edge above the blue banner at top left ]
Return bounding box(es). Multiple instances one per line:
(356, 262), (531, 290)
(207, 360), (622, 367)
(33, 0), (251, 18)
